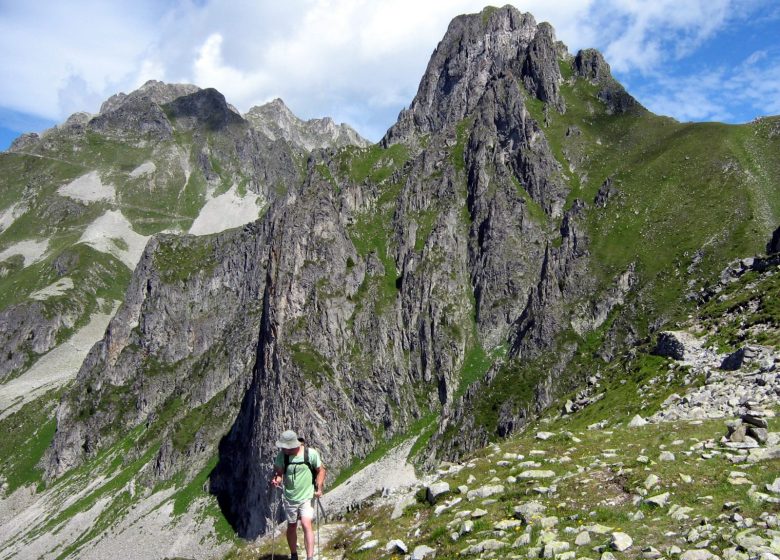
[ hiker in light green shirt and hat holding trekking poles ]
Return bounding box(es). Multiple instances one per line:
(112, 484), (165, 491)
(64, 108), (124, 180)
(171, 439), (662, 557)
(271, 430), (325, 560)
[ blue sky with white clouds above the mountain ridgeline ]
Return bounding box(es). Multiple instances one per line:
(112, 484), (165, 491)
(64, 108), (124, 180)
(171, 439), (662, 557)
(0, 0), (780, 149)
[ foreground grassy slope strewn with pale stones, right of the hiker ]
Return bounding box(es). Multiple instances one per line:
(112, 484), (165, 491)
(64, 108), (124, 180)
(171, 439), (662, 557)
(241, 326), (780, 560)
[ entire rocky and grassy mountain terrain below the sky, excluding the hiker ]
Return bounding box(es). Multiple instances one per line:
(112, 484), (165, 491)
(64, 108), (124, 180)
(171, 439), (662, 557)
(0, 6), (780, 560)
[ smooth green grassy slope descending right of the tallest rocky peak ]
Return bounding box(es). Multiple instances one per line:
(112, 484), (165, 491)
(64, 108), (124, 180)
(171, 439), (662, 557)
(458, 68), (780, 433)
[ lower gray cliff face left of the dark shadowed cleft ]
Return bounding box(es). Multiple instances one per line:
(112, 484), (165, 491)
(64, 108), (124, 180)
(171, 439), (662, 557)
(46, 225), (266, 480)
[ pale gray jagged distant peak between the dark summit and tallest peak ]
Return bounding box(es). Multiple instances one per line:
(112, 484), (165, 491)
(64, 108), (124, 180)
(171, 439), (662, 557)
(244, 99), (371, 152)
